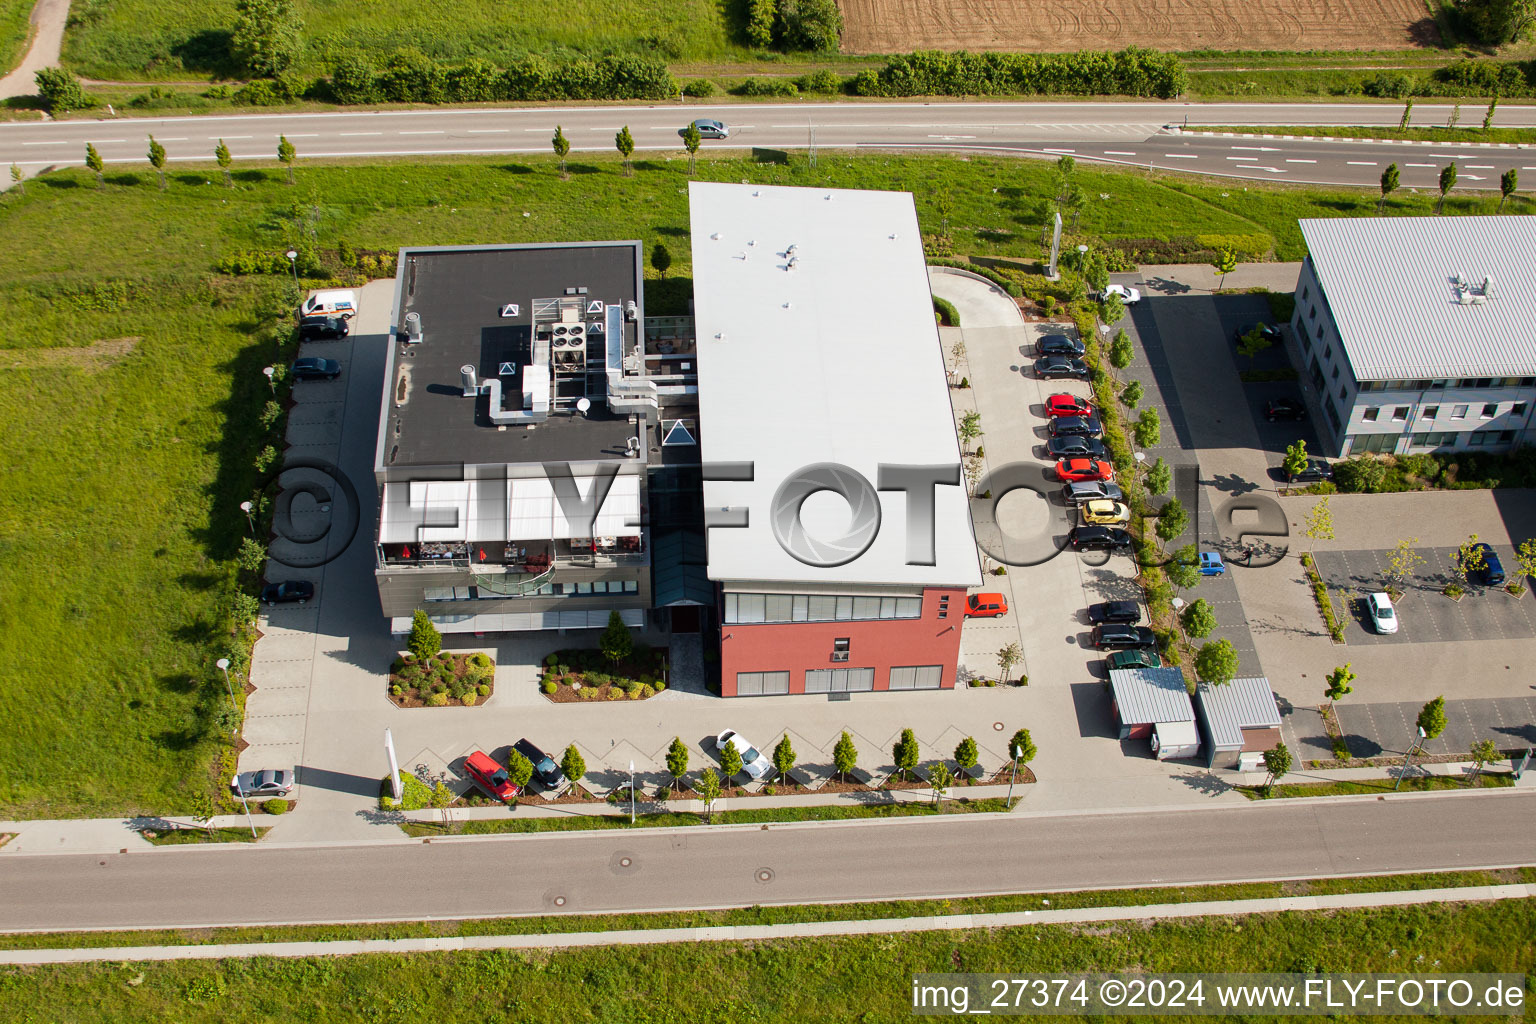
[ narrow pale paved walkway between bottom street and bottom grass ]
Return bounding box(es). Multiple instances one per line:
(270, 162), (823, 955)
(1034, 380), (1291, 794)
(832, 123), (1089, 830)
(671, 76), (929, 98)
(0, 884), (1536, 964)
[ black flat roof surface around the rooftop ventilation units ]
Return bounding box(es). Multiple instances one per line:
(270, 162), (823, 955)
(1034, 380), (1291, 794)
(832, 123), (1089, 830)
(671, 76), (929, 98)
(387, 241), (644, 470)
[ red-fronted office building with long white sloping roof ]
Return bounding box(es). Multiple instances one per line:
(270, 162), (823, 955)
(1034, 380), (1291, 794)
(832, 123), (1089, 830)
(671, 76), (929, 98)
(690, 183), (982, 697)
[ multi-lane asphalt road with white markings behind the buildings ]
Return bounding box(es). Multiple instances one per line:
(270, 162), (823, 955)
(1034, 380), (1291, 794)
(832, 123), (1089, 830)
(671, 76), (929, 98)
(0, 103), (1536, 189)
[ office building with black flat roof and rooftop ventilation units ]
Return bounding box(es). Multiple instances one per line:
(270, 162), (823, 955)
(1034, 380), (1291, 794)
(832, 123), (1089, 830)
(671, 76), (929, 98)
(373, 241), (710, 633)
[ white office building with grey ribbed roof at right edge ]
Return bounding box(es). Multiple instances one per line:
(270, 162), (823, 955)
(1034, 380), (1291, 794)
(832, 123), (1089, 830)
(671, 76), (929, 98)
(1290, 216), (1536, 456)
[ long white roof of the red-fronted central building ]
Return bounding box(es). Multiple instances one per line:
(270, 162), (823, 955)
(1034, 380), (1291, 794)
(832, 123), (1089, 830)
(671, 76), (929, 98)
(688, 181), (982, 586)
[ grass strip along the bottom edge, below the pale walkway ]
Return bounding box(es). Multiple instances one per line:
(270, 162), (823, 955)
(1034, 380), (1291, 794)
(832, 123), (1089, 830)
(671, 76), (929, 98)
(0, 900), (1536, 1024)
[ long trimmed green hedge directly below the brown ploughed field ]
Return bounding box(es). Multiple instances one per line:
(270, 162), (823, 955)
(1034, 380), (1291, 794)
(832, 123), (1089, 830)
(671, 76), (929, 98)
(852, 46), (1189, 100)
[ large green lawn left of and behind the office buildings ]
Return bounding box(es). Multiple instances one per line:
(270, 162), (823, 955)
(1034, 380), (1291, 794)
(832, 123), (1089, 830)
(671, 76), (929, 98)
(0, 149), (1527, 817)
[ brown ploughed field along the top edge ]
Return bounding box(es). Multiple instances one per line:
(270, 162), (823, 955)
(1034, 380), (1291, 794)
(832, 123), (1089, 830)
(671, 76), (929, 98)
(840, 0), (1439, 54)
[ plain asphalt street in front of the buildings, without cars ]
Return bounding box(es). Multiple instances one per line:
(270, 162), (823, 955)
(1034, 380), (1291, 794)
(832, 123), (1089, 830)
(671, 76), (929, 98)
(0, 791), (1536, 930)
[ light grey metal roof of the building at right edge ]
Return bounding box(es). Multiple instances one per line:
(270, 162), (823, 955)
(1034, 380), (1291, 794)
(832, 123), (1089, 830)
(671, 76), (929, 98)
(1301, 216), (1536, 381)
